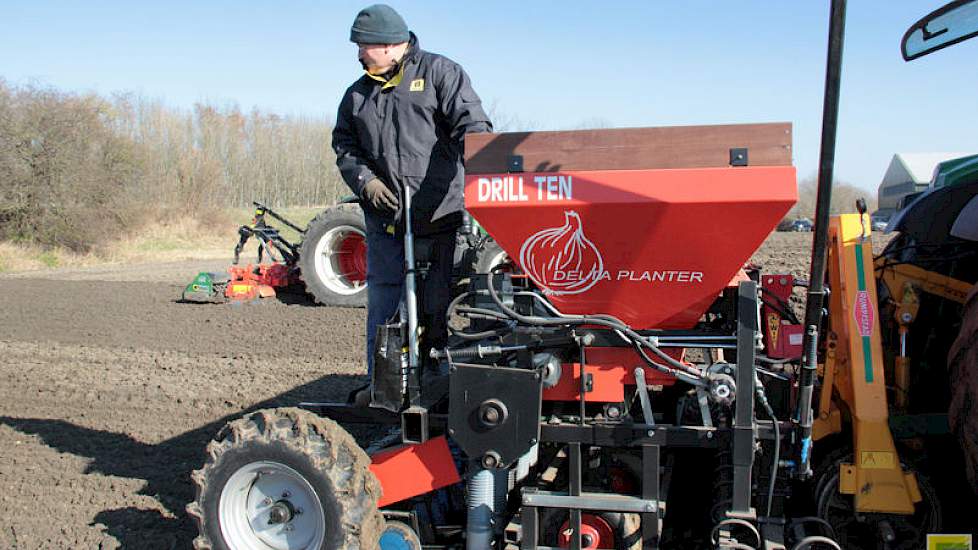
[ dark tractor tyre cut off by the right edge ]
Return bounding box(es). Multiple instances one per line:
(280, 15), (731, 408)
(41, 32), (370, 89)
(948, 286), (978, 494)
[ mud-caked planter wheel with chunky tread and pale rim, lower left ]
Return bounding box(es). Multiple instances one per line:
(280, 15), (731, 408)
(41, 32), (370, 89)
(187, 408), (385, 550)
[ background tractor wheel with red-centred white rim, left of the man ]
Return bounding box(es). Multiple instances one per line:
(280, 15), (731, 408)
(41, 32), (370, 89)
(298, 204), (367, 307)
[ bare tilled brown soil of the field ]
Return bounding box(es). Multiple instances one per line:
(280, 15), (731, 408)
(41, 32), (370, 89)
(0, 234), (968, 549)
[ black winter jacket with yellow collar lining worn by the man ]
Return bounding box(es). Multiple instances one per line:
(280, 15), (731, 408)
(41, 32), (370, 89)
(333, 33), (492, 235)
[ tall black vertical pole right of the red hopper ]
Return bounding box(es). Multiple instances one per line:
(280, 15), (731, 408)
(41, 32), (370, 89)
(796, 0), (846, 476)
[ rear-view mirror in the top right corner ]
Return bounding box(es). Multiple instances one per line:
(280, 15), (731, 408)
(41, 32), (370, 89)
(901, 0), (978, 61)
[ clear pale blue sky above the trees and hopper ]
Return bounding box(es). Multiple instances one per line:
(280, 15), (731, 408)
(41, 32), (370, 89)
(0, 0), (978, 189)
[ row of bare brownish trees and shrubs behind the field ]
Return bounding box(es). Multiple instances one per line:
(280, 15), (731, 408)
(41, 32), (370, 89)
(0, 80), (349, 251)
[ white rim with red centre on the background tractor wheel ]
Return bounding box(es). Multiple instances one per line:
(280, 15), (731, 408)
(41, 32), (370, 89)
(313, 226), (366, 296)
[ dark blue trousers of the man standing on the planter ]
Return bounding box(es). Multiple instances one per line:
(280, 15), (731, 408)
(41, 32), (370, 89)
(366, 214), (456, 375)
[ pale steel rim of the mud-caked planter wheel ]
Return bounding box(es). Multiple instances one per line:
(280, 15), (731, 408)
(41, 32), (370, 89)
(218, 461), (326, 550)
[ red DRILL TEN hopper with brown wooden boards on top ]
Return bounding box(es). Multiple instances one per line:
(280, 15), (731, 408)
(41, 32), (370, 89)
(465, 124), (797, 329)
